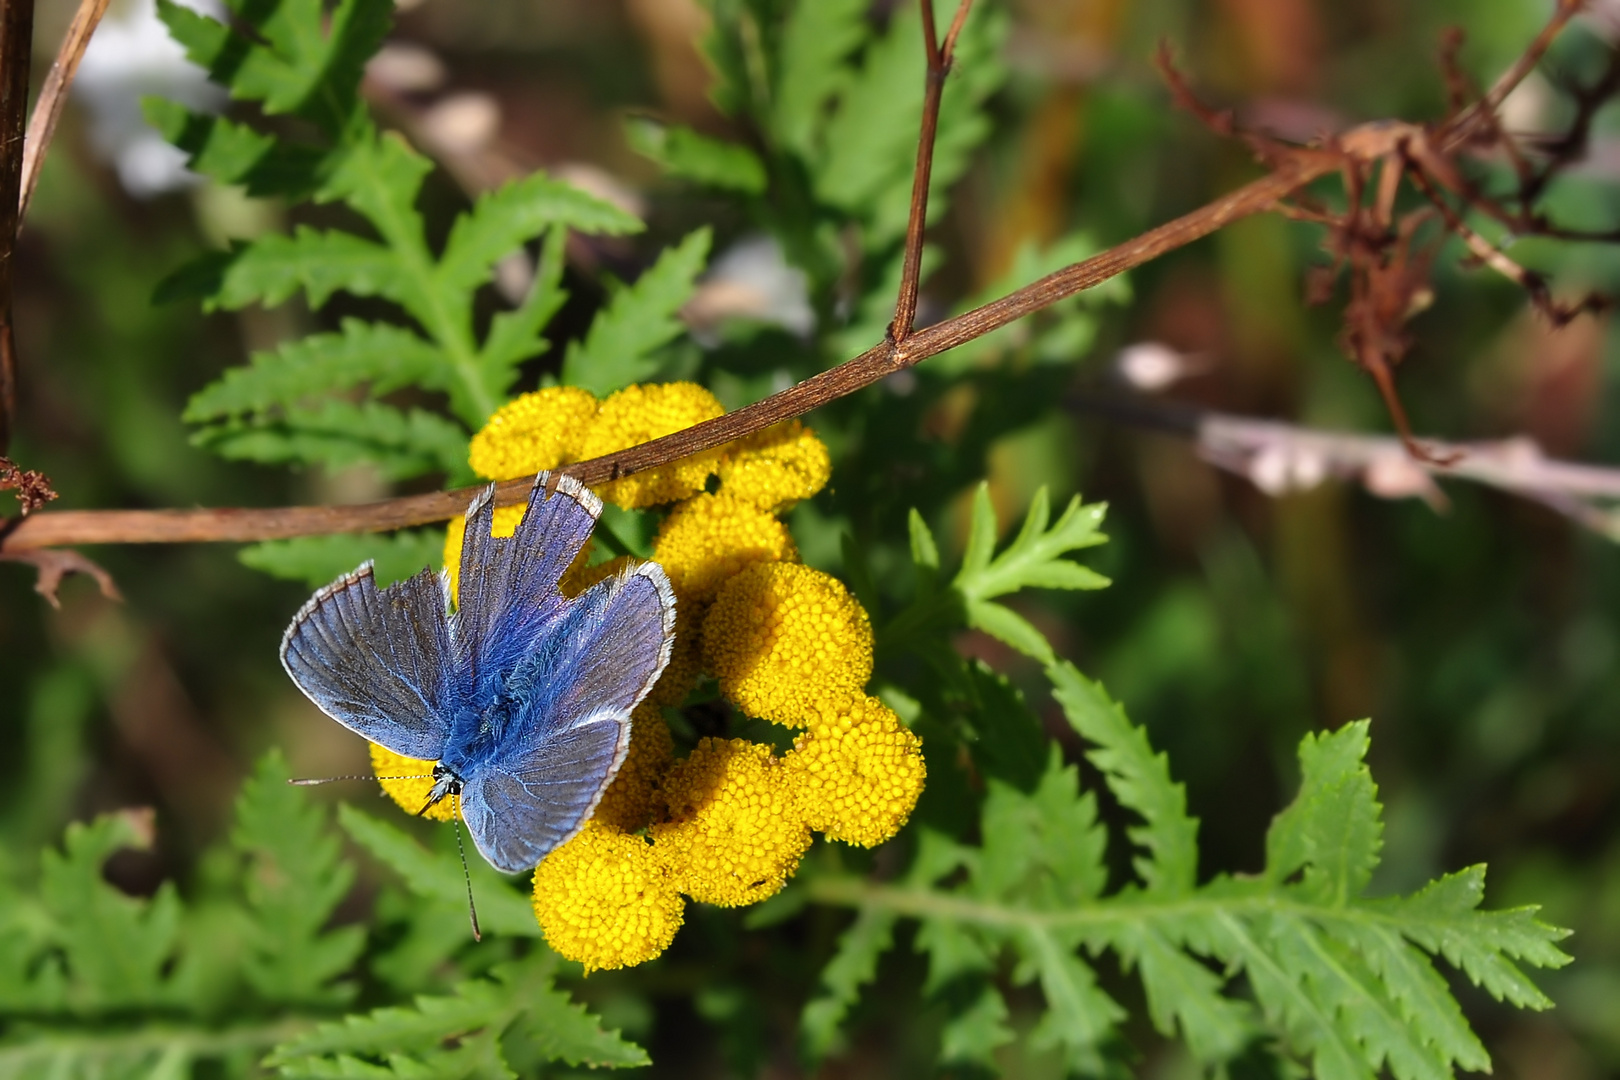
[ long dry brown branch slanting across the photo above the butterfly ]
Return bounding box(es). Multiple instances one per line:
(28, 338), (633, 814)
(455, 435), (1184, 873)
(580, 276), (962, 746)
(0, 0), (1600, 566)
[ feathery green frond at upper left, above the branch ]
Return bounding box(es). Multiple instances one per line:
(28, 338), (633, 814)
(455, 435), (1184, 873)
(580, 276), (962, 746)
(147, 0), (641, 479)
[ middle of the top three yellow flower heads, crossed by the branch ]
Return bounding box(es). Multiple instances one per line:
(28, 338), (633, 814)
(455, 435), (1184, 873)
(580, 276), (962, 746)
(580, 382), (726, 510)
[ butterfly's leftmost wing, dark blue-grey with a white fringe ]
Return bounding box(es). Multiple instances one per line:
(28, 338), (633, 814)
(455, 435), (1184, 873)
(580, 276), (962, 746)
(282, 562), (463, 761)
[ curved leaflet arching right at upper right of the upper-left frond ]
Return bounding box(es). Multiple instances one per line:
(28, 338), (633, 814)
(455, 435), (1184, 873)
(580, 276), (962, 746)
(436, 173), (643, 293)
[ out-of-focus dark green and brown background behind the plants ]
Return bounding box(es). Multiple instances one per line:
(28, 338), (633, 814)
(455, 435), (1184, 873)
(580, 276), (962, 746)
(0, 0), (1620, 1077)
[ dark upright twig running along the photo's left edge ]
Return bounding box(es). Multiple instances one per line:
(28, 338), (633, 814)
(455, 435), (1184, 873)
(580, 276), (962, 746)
(0, 0), (34, 453)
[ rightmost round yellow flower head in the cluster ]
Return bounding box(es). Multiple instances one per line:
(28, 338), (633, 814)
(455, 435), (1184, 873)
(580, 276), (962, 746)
(786, 693), (927, 847)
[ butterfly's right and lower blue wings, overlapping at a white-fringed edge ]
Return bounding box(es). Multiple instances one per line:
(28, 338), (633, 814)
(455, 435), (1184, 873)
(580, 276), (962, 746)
(462, 563), (676, 873)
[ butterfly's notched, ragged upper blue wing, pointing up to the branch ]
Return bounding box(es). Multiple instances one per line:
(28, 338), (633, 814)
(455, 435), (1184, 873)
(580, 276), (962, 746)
(454, 473), (603, 693)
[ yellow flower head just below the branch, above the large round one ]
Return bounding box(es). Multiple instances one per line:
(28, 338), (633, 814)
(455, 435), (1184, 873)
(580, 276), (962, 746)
(653, 494), (799, 606)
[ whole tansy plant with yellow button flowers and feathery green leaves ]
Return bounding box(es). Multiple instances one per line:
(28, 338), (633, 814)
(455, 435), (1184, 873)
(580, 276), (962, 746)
(0, 0), (1568, 1080)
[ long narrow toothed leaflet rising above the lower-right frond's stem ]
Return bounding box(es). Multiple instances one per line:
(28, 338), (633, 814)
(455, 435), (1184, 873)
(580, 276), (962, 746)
(1047, 661), (1199, 897)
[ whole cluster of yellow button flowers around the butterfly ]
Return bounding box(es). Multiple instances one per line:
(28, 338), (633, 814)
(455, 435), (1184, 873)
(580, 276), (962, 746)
(373, 382), (925, 970)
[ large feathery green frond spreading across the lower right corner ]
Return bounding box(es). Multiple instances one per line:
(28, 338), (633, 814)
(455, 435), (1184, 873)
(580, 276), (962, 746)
(813, 662), (1568, 1080)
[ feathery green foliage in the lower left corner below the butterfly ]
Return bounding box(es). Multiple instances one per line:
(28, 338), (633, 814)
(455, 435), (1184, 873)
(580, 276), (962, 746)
(0, 753), (646, 1080)
